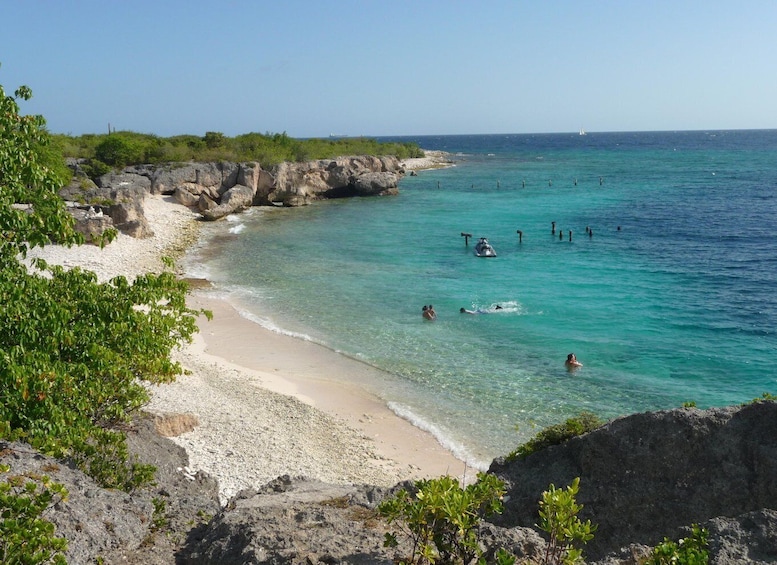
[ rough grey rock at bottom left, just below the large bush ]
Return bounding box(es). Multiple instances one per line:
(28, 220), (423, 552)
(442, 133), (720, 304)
(0, 418), (219, 565)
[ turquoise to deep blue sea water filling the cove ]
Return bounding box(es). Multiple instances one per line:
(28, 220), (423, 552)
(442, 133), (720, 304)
(183, 130), (777, 467)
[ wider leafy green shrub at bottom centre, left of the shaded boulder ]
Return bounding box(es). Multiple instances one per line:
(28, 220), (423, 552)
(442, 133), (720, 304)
(378, 473), (509, 563)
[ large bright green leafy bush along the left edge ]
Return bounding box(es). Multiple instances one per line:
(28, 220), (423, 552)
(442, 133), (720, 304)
(0, 74), (206, 490)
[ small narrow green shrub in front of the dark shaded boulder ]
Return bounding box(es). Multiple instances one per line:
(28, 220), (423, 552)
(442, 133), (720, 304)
(537, 477), (597, 565)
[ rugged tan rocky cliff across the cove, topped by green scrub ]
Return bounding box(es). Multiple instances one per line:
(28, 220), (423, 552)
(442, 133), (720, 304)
(60, 155), (405, 237)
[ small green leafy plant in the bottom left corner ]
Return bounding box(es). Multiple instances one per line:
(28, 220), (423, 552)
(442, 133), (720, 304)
(0, 465), (68, 565)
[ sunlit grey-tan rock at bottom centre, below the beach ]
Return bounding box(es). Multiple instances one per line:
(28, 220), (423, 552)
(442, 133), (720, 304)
(182, 476), (544, 565)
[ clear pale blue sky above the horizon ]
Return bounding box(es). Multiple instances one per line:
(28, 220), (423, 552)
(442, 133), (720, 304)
(0, 0), (777, 137)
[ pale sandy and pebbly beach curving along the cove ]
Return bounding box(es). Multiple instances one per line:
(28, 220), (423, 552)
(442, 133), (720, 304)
(29, 196), (466, 503)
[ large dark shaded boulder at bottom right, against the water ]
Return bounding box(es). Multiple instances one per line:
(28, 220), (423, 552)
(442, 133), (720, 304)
(489, 402), (777, 558)
